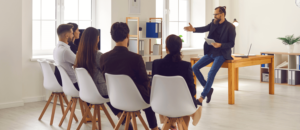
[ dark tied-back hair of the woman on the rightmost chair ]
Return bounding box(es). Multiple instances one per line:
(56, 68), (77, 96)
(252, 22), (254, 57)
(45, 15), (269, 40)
(166, 34), (182, 62)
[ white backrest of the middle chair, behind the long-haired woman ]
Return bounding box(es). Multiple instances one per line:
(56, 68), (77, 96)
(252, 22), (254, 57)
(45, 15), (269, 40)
(75, 68), (109, 104)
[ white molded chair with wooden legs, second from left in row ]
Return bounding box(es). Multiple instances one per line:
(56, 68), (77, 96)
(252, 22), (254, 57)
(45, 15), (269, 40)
(55, 64), (86, 130)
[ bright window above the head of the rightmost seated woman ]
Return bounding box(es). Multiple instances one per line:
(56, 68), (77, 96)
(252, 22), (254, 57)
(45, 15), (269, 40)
(156, 0), (190, 47)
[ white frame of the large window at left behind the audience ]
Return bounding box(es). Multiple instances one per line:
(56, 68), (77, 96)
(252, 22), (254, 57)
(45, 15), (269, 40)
(31, 0), (96, 56)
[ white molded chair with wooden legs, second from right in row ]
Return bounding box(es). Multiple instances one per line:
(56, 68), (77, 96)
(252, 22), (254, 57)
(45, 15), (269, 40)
(105, 73), (150, 130)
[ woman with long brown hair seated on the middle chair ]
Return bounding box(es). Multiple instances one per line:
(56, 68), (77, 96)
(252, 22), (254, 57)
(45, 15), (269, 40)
(74, 27), (123, 123)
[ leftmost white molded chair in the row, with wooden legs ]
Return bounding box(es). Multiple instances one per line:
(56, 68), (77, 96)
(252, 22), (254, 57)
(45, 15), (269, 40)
(38, 60), (68, 125)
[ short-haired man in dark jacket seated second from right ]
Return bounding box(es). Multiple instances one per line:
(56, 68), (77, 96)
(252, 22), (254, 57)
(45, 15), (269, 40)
(100, 22), (158, 130)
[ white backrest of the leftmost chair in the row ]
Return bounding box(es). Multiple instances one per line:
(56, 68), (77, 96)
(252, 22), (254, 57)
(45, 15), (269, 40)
(38, 60), (62, 92)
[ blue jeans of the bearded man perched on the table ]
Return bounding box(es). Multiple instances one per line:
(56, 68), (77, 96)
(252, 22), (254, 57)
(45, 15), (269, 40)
(193, 55), (225, 99)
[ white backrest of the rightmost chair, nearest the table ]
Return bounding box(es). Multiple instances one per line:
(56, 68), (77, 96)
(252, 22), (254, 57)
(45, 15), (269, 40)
(150, 75), (196, 117)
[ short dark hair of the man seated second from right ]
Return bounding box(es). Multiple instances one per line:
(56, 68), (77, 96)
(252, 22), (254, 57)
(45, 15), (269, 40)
(110, 22), (129, 42)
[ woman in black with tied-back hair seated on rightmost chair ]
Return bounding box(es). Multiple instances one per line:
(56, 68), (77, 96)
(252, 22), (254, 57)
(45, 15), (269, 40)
(152, 35), (202, 129)
